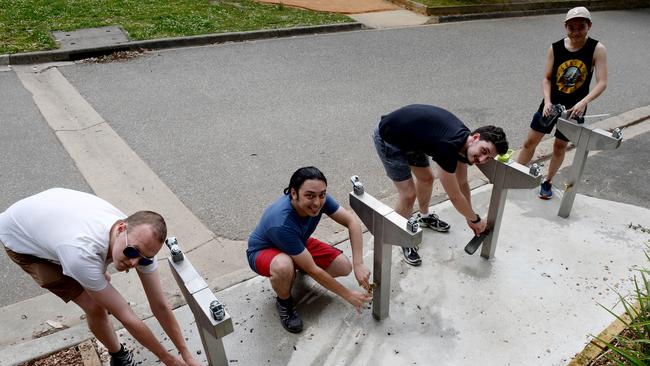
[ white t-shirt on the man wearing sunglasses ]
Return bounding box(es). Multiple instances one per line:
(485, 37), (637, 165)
(0, 188), (158, 291)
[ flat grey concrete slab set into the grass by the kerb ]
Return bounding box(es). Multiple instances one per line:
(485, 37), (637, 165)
(52, 25), (129, 50)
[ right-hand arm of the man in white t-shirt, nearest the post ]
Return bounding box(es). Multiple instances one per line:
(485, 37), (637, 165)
(137, 270), (199, 366)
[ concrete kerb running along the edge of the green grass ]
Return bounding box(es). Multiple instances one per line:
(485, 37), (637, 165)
(0, 22), (364, 65)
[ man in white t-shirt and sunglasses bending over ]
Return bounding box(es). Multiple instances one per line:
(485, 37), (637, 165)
(0, 188), (199, 366)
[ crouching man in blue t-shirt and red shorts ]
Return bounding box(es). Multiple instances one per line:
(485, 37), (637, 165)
(246, 167), (370, 333)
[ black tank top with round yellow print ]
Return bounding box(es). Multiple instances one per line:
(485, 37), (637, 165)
(542, 38), (598, 109)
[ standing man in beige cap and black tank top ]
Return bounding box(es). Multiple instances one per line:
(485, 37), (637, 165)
(517, 6), (607, 199)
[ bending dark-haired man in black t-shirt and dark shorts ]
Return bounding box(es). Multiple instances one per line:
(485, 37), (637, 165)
(373, 104), (508, 266)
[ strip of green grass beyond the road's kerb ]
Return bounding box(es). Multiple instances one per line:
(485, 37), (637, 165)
(0, 0), (351, 54)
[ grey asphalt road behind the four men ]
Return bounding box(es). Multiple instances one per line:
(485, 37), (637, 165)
(0, 9), (650, 305)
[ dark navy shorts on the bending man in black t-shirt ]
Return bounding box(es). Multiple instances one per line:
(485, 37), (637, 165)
(372, 128), (429, 182)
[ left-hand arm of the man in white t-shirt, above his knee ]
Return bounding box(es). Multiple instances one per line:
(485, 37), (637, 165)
(86, 283), (184, 365)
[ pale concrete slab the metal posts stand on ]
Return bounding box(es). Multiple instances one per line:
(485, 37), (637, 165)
(106, 186), (650, 366)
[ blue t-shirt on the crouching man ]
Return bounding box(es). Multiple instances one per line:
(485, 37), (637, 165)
(246, 194), (340, 270)
